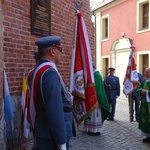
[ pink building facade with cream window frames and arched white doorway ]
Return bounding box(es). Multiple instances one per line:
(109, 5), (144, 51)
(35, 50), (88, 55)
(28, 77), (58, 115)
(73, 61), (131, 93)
(93, 0), (150, 91)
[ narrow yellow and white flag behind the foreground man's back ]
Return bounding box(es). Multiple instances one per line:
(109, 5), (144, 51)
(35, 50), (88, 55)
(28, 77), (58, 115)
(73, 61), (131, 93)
(21, 75), (30, 138)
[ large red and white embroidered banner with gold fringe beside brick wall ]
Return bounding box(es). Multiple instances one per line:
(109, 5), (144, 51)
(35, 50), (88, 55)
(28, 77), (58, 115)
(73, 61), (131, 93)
(70, 11), (98, 125)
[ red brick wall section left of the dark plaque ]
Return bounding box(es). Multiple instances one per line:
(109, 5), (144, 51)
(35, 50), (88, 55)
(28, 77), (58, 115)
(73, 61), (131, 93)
(2, 0), (36, 95)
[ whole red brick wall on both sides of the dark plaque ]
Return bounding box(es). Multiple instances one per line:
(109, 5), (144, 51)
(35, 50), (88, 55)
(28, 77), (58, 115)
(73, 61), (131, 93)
(2, 0), (94, 95)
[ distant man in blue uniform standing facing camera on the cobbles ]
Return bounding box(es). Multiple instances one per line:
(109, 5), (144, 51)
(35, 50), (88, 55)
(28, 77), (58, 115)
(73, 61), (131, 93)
(104, 68), (120, 121)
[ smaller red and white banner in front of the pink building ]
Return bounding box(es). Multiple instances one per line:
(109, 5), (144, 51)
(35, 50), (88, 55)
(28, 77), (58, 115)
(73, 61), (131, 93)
(123, 45), (139, 95)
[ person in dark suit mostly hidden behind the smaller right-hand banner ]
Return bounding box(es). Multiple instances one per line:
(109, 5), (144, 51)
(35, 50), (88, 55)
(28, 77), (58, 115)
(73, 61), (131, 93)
(128, 73), (143, 122)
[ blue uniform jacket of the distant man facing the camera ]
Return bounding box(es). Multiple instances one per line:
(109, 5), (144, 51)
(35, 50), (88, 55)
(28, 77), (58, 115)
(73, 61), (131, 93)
(104, 75), (120, 99)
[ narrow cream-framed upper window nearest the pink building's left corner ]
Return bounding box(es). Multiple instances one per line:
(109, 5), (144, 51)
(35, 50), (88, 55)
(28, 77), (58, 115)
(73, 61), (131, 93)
(101, 15), (109, 40)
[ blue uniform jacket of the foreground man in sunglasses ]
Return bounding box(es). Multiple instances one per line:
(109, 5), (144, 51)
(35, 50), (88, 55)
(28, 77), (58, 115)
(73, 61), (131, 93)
(32, 60), (72, 145)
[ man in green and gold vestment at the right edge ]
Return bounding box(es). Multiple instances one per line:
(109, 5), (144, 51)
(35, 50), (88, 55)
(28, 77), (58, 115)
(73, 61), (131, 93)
(137, 68), (150, 143)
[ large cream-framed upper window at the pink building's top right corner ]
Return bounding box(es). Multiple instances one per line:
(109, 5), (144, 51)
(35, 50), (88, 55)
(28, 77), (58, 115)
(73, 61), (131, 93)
(137, 0), (150, 32)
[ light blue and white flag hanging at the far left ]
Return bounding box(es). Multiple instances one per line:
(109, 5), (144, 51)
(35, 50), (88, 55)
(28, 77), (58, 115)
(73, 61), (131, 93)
(4, 70), (14, 140)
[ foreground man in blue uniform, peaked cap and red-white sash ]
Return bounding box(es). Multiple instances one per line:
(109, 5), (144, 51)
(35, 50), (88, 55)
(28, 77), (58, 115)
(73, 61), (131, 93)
(29, 36), (73, 150)
